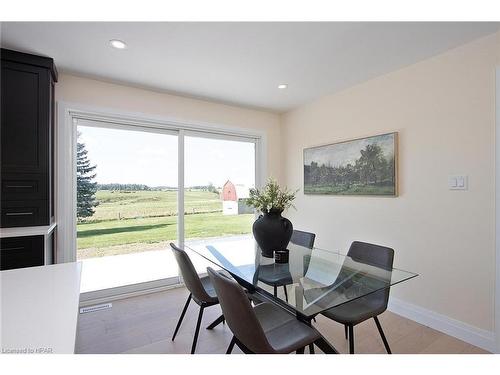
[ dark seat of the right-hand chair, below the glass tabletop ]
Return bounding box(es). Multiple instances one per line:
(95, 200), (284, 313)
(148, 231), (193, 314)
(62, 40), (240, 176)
(322, 292), (386, 325)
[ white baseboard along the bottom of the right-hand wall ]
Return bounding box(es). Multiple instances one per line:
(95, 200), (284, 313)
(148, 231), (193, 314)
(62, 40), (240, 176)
(388, 297), (497, 353)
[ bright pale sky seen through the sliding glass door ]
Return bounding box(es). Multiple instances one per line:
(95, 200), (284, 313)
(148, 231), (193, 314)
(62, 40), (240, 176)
(78, 126), (255, 187)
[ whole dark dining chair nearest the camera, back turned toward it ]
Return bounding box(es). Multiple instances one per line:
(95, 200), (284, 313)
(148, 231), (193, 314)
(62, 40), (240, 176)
(207, 268), (321, 354)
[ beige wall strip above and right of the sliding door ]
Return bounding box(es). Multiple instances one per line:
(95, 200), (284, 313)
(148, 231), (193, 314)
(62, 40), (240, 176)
(56, 74), (281, 179)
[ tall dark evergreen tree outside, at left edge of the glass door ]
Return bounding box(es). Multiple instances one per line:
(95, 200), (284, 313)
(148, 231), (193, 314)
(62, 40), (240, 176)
(76, 132), (99, 219)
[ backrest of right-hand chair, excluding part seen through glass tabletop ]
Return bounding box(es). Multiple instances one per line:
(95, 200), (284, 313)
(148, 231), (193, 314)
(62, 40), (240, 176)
(347, 241), (394, 309)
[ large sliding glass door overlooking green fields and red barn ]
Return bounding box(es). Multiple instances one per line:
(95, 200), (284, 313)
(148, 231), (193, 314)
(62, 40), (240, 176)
(76, 120), (257, 296)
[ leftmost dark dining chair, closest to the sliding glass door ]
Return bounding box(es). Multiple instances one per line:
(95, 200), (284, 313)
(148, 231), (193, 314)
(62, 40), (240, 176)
(170, 243), (224, 354)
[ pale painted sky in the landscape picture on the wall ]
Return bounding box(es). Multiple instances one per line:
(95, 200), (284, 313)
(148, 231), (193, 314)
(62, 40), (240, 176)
(304, 133), (394, 167)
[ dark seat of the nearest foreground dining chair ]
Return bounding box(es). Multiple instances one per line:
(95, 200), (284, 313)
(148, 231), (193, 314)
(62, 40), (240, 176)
(254, 302), (321, 353)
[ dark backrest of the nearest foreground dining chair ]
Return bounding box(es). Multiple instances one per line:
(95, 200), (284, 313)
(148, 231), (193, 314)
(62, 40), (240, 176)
(207, 267), (273, 353)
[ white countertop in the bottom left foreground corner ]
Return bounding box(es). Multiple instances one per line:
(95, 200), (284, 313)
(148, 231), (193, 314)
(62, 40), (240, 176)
(0, 262), (82, 353)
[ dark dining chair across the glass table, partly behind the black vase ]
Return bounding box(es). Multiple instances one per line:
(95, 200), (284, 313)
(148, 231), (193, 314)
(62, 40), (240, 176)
(258, 230), (316, 302)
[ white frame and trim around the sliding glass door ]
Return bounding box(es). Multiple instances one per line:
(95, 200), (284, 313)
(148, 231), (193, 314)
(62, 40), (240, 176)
(54, 101), (267, 300)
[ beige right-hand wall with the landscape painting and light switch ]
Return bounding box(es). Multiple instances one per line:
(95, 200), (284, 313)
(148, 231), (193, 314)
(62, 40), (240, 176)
(281, 34), (500, 331)
